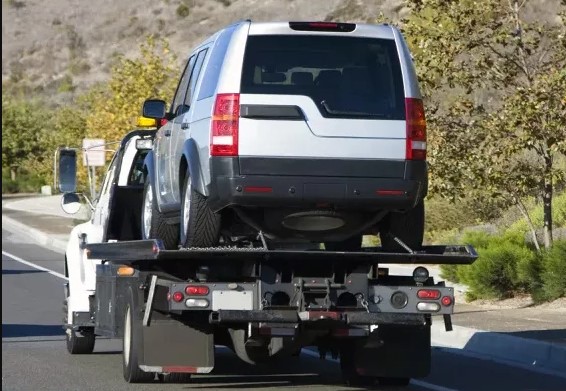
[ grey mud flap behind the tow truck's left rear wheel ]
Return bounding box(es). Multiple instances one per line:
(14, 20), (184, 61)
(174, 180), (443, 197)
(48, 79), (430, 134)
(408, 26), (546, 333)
(140, 319), (214, 373)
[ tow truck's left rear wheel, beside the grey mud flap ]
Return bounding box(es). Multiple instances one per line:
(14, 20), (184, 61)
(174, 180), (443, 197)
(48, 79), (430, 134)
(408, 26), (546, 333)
(122, 289), (155, 383)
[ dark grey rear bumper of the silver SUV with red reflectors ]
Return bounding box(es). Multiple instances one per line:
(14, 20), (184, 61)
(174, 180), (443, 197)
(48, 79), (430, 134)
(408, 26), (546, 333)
(208, 158), (427, 211)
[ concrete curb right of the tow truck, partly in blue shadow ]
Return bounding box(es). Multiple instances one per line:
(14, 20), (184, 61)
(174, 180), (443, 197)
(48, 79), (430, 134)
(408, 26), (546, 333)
(431, 320), (566, 379)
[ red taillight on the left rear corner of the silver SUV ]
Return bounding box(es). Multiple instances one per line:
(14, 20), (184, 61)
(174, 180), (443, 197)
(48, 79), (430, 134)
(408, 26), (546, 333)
(210, 94), (240, 156)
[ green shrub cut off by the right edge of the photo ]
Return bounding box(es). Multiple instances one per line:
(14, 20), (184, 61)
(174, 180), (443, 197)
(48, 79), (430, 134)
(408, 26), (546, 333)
(541, 240), (566, 300)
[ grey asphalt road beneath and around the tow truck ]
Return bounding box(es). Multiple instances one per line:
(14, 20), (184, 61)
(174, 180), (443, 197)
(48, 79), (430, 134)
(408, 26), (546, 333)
(2, 229), (566, 391)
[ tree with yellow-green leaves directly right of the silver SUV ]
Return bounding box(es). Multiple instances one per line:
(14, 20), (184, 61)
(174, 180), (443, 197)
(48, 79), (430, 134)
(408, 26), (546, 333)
(403, 0), (566, 246)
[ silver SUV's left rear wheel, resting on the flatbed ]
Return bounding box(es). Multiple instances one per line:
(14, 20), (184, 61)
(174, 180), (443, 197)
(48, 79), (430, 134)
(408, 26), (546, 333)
(180, 172), (220, 248)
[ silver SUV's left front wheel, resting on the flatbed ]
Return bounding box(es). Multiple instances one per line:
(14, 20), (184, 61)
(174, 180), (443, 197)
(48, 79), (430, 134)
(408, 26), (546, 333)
(141, 178), (177, 250)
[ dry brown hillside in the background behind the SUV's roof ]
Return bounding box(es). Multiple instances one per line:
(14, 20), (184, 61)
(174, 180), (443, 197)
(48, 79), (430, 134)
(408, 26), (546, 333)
(2, 0), (408, 94)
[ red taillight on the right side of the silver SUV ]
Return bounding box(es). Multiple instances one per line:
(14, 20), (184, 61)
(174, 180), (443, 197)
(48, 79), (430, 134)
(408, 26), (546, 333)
(405, 98), (426, 160)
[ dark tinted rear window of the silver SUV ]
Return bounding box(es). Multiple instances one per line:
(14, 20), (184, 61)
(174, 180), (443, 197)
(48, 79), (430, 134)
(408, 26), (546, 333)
(240, 35), (405, 120)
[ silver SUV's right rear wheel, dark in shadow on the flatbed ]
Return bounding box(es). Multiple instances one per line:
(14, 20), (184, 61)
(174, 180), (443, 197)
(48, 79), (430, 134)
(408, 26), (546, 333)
(379, 201), (425, 252)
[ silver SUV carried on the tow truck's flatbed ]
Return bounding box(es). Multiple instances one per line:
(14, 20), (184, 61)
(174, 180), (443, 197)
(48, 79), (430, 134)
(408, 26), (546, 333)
(142, 21), (427, 251)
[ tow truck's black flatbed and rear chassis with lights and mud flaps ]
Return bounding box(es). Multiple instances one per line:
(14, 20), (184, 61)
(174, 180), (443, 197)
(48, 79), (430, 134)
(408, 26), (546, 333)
(73, 240), (477, 385)
